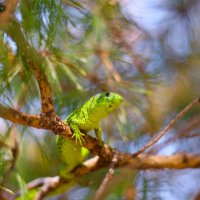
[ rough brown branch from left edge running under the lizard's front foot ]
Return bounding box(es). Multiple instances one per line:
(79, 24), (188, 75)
(0, 101), (118, 159)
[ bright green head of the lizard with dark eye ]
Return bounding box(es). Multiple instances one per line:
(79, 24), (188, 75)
(91, 92), (123, 118)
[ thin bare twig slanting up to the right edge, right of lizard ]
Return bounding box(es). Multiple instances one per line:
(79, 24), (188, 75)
(132, 98), (200, 157)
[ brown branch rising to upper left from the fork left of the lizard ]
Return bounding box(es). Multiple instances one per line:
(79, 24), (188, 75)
(5, 20), (54, 113)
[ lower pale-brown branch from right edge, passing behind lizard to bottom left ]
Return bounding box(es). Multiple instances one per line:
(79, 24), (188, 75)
(18, 153), (200, 199)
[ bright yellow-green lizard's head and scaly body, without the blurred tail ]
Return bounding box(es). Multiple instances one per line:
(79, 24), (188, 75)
(57, 92), (123, 172)
